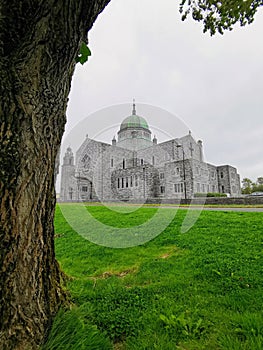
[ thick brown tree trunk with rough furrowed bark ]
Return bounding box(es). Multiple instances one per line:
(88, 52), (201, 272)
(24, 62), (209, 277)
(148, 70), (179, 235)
(0, 0), (110, 350)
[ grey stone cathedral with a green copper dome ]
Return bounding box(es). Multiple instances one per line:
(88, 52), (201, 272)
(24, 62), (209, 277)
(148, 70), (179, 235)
(60, 103), (241, 202)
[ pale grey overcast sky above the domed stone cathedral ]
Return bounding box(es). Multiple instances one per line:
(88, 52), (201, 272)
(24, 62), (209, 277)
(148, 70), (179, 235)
(63, 0), (263, 180)
